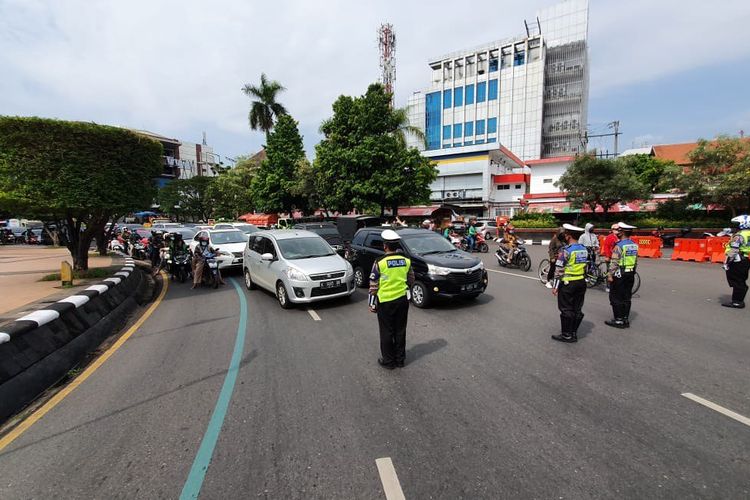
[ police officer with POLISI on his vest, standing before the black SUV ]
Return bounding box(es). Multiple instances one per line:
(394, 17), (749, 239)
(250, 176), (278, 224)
(369, 229), (414, 369)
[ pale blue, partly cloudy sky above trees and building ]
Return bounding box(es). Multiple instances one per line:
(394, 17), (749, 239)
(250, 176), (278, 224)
(0, 0), (750, 162)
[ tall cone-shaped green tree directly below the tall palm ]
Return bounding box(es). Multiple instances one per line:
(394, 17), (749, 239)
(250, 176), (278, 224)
(251, 115), (305, 212)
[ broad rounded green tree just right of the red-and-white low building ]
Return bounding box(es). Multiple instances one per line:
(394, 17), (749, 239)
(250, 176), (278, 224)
(555, 155), (650, 214)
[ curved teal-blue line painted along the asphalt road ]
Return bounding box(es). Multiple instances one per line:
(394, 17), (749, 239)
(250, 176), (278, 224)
(180, 278), (247, 500)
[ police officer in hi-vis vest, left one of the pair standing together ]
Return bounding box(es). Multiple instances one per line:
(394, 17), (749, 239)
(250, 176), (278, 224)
(552, 224), (589, 342)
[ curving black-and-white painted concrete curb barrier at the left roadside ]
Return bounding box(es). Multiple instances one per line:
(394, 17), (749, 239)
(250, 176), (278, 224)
(0, 262), (150, 421)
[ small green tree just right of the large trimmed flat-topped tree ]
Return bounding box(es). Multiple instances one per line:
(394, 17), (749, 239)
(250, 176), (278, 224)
(159, 175), (217, 221)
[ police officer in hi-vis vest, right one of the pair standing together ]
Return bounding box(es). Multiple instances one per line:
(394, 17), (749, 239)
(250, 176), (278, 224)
(604, 222), (638, 328)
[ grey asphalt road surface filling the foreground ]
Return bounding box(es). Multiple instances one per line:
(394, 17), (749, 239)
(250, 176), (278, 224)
(0, 247), (750, 500)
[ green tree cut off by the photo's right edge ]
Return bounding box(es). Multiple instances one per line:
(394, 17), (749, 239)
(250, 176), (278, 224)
(677, 137), (750, 216)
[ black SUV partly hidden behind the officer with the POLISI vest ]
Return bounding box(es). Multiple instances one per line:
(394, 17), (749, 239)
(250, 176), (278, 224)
(346, 227), (487, 307)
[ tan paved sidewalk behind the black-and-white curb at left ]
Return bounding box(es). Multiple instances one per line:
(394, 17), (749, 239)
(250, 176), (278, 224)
(0, 245), (117, 323)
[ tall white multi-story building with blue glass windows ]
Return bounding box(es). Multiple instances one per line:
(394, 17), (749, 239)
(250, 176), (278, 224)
(408, 0), (588, 216)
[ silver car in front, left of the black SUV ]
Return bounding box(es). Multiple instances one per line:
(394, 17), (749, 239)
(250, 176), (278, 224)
(242, 229), (355, 309)
